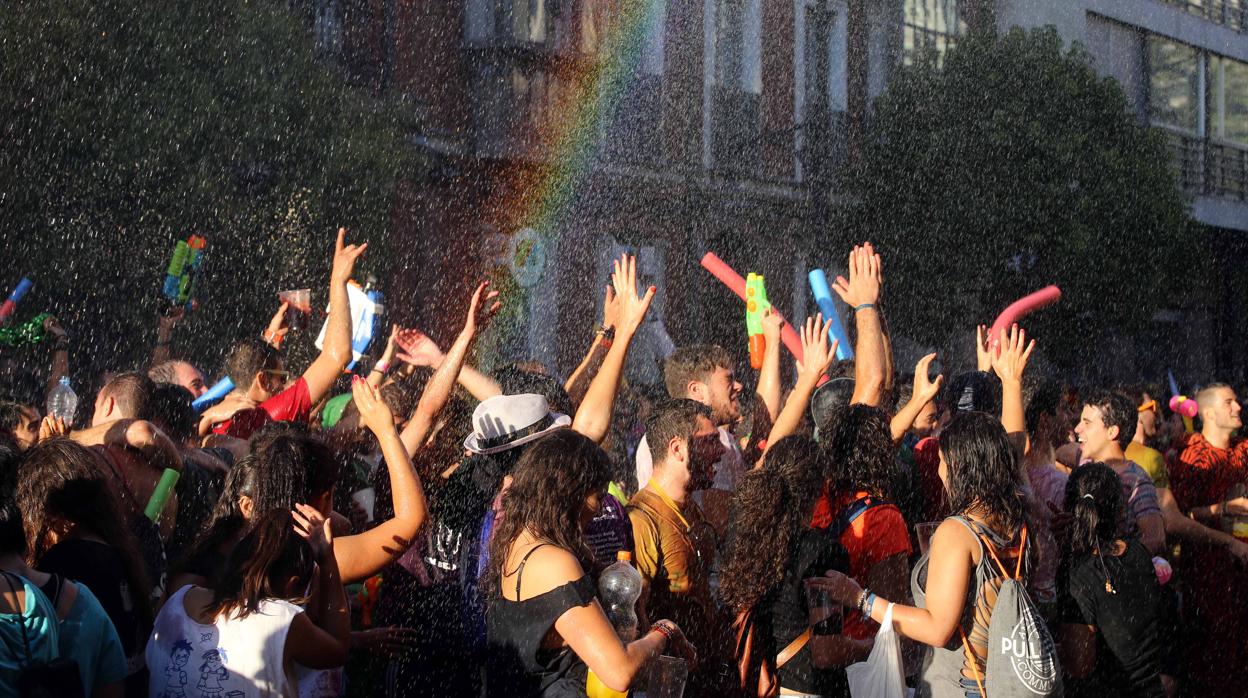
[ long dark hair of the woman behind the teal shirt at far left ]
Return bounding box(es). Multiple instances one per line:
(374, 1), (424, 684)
(16, 437), (152, 628)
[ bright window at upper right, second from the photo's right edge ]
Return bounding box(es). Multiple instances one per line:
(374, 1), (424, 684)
(1148, 36), (1204, 135)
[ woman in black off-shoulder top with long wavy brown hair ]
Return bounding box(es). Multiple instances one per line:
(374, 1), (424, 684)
(482, 430), (691, 698)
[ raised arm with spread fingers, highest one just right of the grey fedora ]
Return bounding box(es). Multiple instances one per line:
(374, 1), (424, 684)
(572, 255), (654, 443)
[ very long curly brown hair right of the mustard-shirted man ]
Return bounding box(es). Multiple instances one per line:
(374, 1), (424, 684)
(719, 436), (824, 612)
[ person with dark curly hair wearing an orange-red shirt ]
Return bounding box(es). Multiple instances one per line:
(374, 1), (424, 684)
(819, 403), (910, 644)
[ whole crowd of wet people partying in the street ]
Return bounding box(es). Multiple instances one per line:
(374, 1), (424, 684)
(0, 230), (1248, 698)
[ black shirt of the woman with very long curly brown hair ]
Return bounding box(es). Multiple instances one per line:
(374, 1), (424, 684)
(755, 528), (850, 696)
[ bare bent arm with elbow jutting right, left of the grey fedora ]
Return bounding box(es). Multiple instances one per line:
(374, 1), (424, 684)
(333, 376), (426, 584)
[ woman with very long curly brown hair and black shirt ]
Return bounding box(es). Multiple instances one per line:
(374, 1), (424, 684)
(719, 436), (871, 696)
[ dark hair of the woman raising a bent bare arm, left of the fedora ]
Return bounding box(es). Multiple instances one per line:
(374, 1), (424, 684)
(251, 428), (339, 512)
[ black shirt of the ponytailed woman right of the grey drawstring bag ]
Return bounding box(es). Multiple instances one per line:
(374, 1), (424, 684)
(1058, 538), (1164, 698)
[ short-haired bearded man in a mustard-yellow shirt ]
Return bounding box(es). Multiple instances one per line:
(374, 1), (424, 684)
(628, 399), (740, 687)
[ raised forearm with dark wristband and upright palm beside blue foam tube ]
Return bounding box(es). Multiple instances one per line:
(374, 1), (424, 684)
(832, 242), (889, 406)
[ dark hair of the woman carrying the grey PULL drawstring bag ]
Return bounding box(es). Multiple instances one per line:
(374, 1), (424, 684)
(940, 412), (1027, 532)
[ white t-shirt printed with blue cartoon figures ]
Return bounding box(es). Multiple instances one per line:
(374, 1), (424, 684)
(146, 584), (303, 698)
